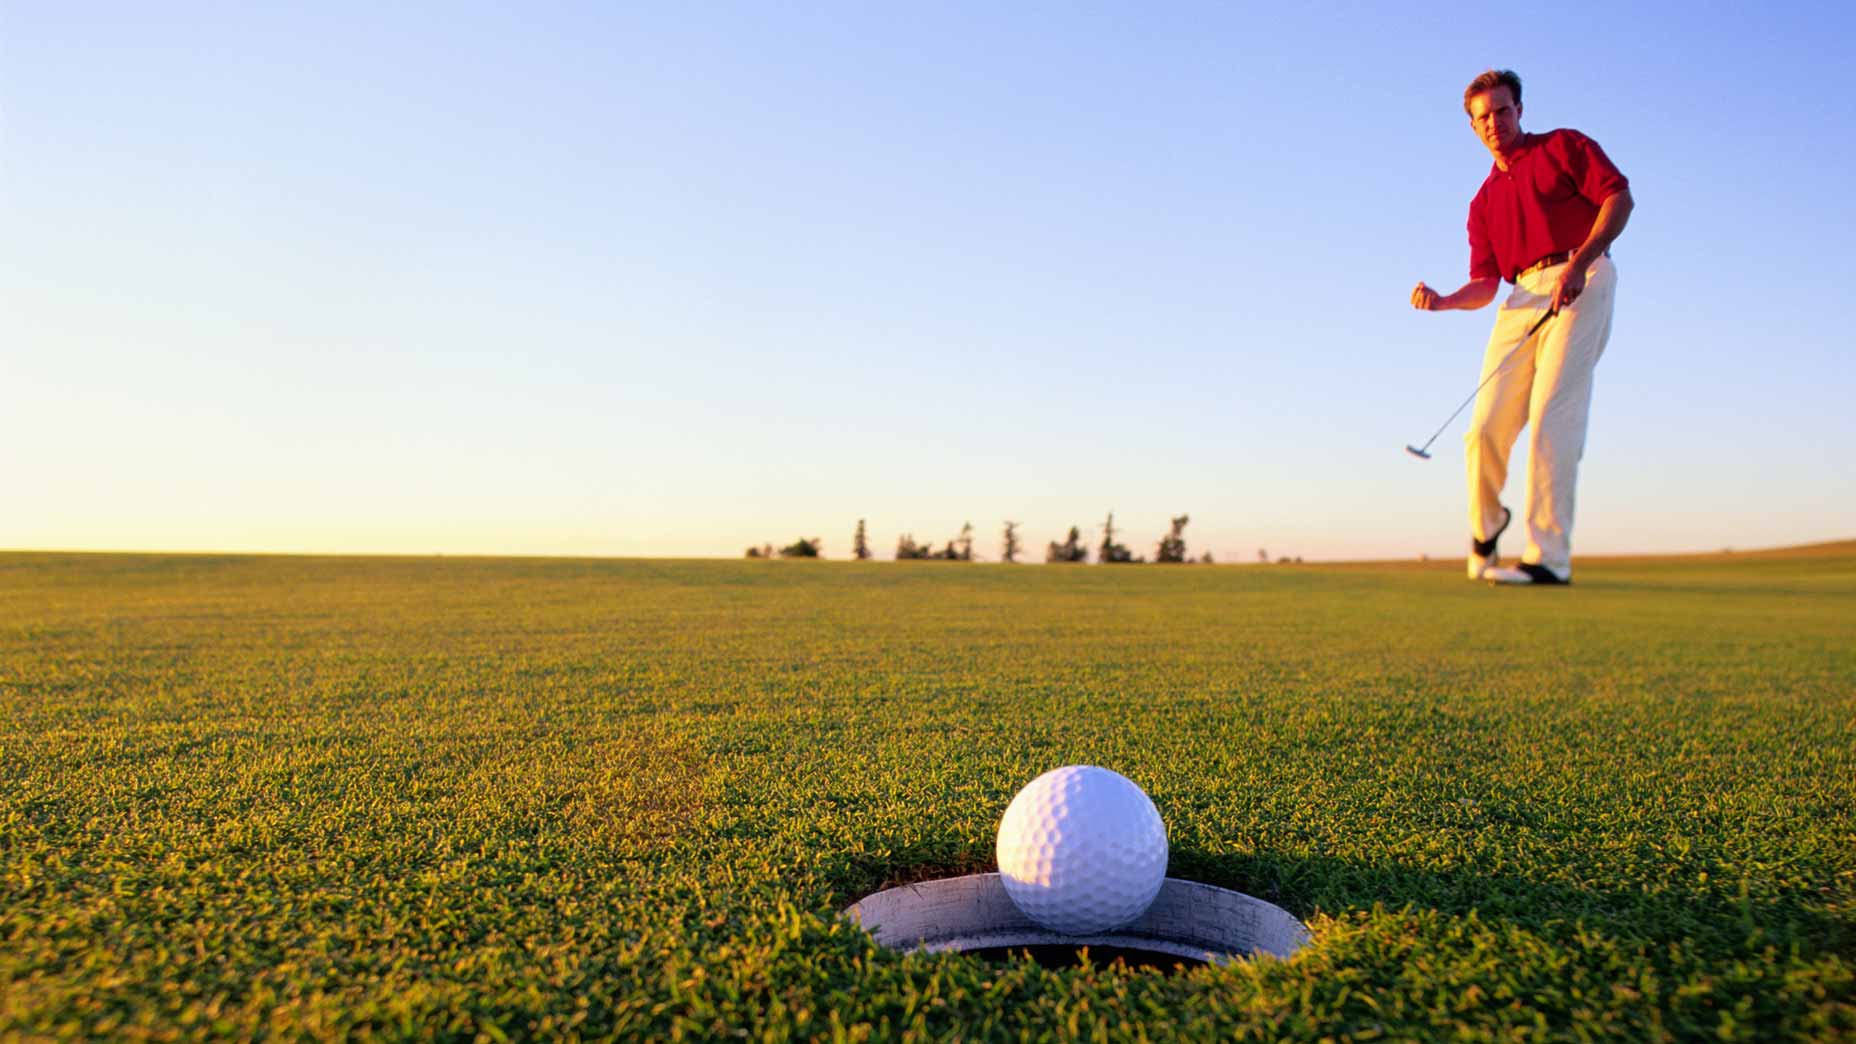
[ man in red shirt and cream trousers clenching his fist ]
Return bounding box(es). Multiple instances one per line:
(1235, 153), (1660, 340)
(1411, 69), (1633, 583)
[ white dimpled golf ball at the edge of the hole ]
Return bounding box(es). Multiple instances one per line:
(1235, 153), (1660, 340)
(999, 765), (1166, 934)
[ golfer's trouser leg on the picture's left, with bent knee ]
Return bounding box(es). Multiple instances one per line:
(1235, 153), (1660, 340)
(1463, 292), (1557, 580)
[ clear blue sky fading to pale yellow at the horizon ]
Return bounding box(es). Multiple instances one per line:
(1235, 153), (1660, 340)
(0, 0), (1856, 561)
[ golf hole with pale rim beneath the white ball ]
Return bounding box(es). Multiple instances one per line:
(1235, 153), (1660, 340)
(844, 873), (1308, 972)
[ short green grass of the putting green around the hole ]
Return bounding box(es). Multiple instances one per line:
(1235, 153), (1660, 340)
(0, 548), (1856, 1040)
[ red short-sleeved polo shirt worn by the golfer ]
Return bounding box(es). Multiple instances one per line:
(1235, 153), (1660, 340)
(1470, 130), (1630, 282)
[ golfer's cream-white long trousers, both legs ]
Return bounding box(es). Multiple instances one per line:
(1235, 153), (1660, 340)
(1463, 258), (1617, 576)
